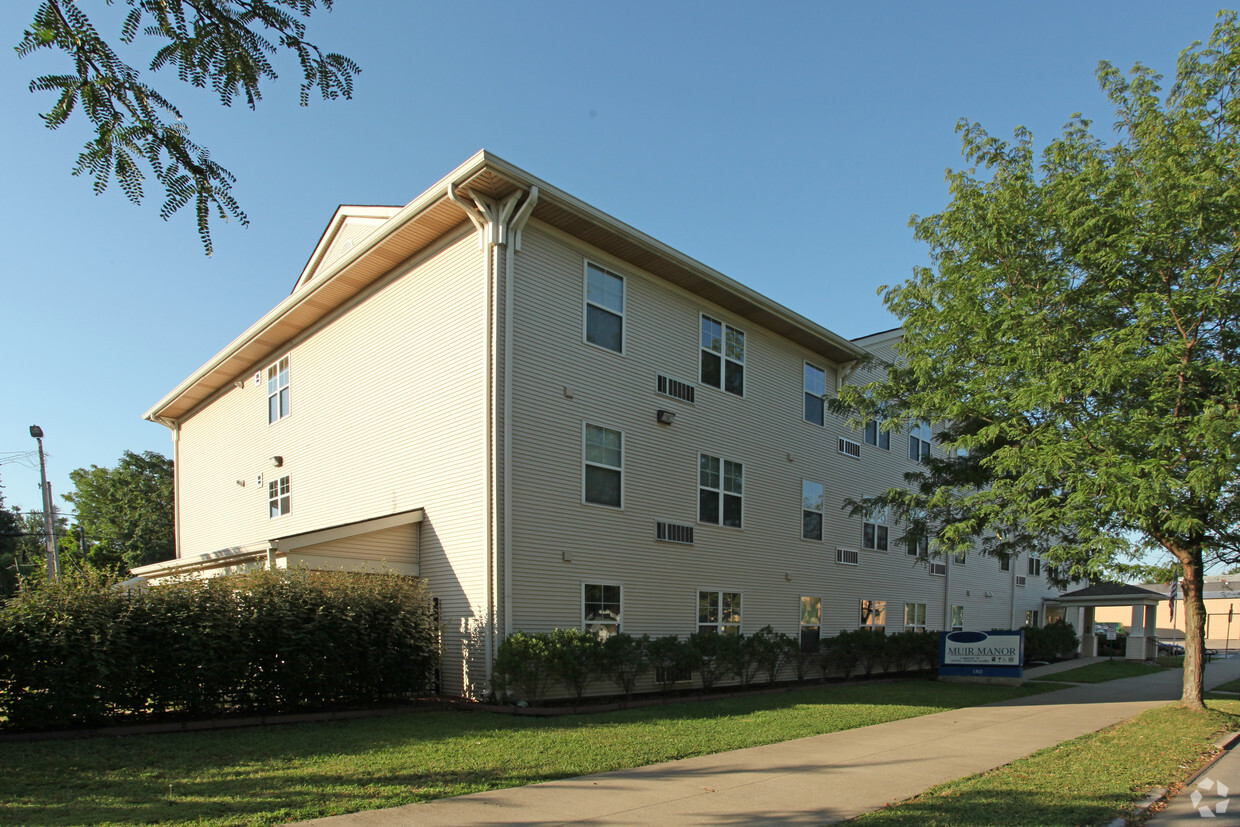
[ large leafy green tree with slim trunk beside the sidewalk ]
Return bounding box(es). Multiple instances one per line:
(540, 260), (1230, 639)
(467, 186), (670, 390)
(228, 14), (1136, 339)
(841, 12), (1240, 708)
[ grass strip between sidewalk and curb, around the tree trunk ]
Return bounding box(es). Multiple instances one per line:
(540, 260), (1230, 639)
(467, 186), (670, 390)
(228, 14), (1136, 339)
(856, 701), (1240, 827)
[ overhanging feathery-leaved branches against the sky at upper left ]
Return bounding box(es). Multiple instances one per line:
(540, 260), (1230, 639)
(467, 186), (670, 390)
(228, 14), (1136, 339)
(16, 0), (361, 255)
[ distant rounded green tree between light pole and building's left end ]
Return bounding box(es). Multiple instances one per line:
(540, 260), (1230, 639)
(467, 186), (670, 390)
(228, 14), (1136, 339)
(64, 451), (176, 572)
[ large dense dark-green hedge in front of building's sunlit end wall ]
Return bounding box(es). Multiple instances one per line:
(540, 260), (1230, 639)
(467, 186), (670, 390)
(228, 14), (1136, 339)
(0, 569), (439, 730)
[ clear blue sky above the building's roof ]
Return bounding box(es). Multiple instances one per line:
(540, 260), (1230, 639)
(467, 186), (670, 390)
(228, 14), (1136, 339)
(0, 0), (1219, 518)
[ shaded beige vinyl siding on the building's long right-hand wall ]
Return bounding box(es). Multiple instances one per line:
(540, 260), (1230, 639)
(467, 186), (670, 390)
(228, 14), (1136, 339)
(498, 222), (1061, 635)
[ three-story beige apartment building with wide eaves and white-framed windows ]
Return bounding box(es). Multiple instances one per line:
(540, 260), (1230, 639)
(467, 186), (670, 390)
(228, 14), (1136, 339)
(135, 151), (1056, 694)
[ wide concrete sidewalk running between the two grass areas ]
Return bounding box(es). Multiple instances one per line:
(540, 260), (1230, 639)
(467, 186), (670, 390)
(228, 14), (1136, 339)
(290, 658), (1240, 827)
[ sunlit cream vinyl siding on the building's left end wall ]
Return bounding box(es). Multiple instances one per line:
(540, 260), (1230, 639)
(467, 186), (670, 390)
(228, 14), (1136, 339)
(177, 233), (487, 692)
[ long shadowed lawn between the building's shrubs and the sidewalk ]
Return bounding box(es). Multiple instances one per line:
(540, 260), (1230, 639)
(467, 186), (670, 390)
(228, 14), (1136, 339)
(0, 681), (1049, 825)
